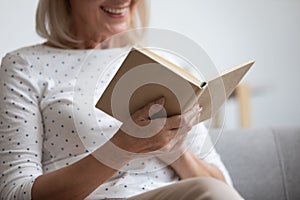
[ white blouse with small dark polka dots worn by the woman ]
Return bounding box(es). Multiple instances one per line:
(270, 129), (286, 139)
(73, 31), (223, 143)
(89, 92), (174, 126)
(0, 44), (231, 200)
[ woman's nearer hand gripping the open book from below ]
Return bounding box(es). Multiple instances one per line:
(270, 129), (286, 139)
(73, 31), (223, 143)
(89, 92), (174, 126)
(111, 98), (201, 153)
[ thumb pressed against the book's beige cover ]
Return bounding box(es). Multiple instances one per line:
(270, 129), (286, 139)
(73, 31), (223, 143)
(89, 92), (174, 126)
(132, 97), (165, 120)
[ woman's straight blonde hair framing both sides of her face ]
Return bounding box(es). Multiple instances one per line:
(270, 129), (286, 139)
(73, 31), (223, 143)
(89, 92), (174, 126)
(36, 0), (149, 48)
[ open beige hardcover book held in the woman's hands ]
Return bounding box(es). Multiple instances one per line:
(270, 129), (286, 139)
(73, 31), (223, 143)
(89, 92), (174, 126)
(96, 48), (254, 122)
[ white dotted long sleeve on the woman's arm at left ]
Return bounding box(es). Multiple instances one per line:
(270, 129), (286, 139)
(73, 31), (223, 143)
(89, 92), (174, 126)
(0, 53), (43, 200)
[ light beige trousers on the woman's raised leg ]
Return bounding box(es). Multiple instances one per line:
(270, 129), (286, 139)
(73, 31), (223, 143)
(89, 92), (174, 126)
(110, 178), (243, 200)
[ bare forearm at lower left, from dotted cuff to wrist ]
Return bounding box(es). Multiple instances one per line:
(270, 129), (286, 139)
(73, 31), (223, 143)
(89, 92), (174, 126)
(32, 136), (135, 200)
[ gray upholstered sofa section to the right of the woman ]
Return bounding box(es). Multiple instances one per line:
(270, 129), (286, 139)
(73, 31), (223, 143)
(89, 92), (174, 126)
(211, 127), (300, 200)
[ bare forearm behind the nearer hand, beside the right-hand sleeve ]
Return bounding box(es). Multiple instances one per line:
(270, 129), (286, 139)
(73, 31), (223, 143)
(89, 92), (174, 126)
(170, 151), (225, 181)
